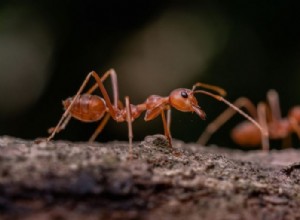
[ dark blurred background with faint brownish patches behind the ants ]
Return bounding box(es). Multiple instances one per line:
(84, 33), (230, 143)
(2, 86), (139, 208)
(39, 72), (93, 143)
(0, 0), (300, 149)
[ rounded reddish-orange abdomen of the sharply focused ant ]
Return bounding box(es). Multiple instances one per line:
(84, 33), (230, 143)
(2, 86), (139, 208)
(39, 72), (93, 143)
(63, 94), (106, 122)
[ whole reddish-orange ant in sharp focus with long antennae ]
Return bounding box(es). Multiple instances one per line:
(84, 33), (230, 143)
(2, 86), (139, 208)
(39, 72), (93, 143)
(47, 69), (266, 155)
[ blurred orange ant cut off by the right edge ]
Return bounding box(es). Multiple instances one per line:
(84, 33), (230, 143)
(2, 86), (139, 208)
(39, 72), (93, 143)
(198, 89), (300, 151)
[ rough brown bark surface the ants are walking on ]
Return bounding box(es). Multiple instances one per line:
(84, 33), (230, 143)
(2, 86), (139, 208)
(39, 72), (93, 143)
(0, 135), (300, 220)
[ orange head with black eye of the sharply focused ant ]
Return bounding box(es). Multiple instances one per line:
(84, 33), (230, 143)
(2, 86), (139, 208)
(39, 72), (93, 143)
(169, 88), (206, 119)
